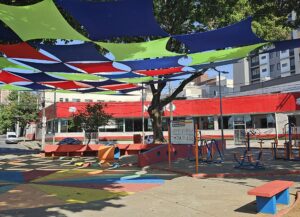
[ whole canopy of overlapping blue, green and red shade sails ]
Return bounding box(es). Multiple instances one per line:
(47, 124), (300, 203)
(0, 0), (300, 94)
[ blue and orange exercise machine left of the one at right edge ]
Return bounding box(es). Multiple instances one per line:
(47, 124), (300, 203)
(233, 130), (265, 170)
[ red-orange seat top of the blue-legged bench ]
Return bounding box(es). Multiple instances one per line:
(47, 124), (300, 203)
(248, 180), (294, 197)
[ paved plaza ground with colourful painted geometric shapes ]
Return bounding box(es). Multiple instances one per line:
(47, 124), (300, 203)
(0, 143), (300, 217)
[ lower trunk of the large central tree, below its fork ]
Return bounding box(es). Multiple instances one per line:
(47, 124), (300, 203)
(149, 109), (166, 143)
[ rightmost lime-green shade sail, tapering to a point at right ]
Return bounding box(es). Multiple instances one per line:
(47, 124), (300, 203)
(188, 43), (266, 66)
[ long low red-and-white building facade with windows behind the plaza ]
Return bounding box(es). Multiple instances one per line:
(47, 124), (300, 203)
(31, 93), (300, 143)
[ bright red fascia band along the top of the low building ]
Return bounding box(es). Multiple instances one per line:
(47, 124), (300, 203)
(46, 93), (300, 118)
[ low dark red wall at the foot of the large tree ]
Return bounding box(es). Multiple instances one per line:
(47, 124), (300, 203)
(138, 145), (191, 167)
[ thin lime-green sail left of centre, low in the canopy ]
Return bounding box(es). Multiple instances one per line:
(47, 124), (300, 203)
(47, 72), (106, 81)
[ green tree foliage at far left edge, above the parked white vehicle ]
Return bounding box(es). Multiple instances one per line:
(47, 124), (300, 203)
(0, 91), (38, 133)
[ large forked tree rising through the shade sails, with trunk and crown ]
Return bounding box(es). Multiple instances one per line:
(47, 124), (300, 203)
(1, 0), (300, 142)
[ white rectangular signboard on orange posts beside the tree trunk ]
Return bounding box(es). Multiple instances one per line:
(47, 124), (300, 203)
(170, 119), (195, 145)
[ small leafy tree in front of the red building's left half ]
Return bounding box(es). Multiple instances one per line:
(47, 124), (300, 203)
(72, 103), (111, 144)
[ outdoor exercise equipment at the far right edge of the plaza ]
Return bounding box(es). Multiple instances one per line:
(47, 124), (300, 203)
(272, 123), (300, 161)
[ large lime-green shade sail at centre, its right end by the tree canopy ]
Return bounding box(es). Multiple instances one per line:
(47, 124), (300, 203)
(95, 37), (180, 61)
